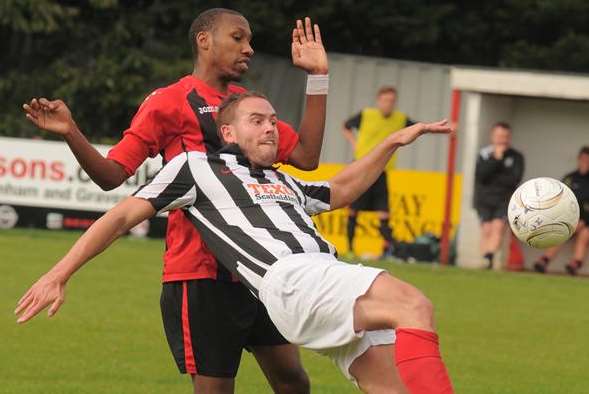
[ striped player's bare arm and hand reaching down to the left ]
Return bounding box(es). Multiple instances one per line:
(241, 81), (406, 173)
(14, 197), (155, 323)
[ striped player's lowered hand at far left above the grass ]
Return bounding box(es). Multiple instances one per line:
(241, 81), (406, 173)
(14, 272), (65, 323)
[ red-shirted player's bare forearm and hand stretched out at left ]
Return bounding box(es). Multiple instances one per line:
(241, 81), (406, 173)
(23, 98), (127, 190)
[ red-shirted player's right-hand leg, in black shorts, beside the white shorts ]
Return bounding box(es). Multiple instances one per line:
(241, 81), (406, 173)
(246, 291), (311, 394)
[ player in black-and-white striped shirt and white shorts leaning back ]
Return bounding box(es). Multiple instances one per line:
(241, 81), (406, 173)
(18, 92), (453, 394)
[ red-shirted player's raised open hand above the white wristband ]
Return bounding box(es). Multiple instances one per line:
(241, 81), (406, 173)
(291, 17), (328, 74)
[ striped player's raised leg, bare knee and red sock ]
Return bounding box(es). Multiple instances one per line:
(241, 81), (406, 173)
(354, 273), (453, 394)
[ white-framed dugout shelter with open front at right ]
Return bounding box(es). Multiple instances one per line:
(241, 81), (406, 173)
(450, 67), (589, 273)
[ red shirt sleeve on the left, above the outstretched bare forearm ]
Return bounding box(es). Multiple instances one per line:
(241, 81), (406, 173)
(107, 90), (179, 176)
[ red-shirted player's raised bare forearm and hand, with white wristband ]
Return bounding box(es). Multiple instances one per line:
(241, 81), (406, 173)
(289, 17), (329, 170)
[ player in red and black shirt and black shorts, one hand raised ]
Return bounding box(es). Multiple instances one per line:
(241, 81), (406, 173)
(22, 8), (328, 393)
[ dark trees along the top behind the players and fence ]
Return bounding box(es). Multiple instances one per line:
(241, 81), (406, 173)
(0, 0), (589, 142)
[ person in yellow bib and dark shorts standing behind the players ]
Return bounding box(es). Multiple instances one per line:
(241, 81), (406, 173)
(342, 86), (415, 258)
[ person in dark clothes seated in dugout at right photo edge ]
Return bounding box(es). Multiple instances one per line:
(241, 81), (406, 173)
(534, 146), (589, 275)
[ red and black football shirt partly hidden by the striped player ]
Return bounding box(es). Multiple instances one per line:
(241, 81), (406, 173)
(107, 75), (298, 282)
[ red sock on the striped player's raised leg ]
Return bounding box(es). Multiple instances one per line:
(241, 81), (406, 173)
(395, 328), (454, 394)
